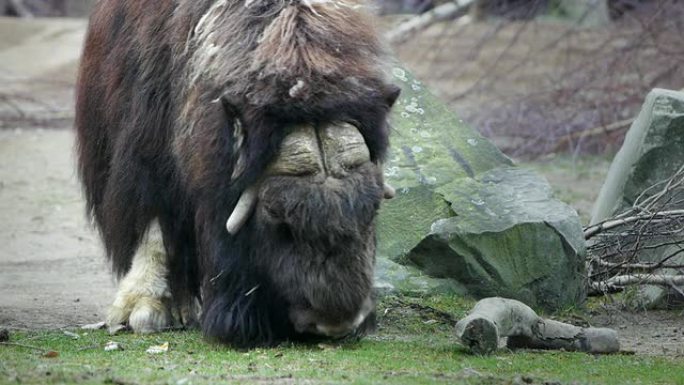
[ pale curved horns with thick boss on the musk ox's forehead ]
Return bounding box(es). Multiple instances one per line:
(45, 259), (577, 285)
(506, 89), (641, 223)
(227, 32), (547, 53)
(226, 122), (395, 235)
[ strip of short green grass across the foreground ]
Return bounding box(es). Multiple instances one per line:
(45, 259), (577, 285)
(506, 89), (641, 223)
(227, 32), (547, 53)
(0, 296), (684, 385)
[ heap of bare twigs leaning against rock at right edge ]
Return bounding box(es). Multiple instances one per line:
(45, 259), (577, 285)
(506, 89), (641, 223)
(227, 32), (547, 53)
(584, 165), (684, 297)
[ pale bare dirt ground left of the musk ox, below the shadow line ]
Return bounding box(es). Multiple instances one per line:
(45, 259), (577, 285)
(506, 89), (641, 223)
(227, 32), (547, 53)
(0, 129), (113, 329)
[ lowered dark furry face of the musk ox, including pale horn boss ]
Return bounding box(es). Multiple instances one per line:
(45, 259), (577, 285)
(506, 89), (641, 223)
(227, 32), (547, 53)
(252, 124), (386, 337)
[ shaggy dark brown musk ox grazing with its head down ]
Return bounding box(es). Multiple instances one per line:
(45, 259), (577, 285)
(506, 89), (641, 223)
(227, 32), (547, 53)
(76, 0), (399, 347)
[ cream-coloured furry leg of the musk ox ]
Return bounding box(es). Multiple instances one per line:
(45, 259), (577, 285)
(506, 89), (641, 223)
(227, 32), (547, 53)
(107, 222), (174, 334)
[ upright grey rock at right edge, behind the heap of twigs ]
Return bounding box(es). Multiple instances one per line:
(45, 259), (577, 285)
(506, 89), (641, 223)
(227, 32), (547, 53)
(591, 89), (684, 308)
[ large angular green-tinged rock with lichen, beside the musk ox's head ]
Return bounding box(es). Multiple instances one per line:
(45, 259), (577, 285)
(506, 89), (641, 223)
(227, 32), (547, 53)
(378, 68), (585, 309)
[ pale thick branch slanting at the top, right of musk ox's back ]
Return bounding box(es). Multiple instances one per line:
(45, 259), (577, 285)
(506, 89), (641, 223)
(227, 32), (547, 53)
(385, 0), (475, 43)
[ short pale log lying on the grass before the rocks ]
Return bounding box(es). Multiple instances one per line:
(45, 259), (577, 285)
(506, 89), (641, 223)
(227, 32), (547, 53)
(456, 297), (620, 354)
